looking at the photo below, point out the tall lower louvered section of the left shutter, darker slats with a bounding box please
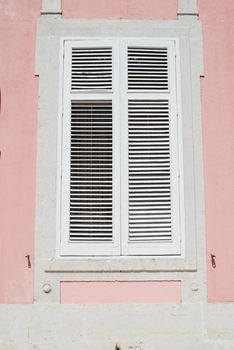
[70,101,112,242]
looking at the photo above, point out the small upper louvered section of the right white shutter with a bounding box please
[128,47,168,90]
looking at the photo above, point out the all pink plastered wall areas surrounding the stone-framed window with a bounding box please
[0,0,234,303]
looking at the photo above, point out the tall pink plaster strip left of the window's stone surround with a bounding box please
[0,0,40,303]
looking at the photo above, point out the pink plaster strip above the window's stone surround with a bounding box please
[62,0,178,19]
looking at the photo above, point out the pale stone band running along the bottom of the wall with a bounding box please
[0,304,234,350]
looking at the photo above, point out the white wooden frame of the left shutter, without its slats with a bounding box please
[60,40,120,256]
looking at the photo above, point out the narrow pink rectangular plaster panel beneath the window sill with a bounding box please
[60,281,181,304]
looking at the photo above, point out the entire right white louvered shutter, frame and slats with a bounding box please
[122,40,180,255]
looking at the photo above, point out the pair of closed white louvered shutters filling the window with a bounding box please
[60,38,183,256]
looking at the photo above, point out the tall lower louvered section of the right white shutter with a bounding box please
[128,100,172,242]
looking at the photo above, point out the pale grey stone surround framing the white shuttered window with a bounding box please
[35,16,206,302]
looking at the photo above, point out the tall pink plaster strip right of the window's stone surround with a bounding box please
[199,0,234,301]
